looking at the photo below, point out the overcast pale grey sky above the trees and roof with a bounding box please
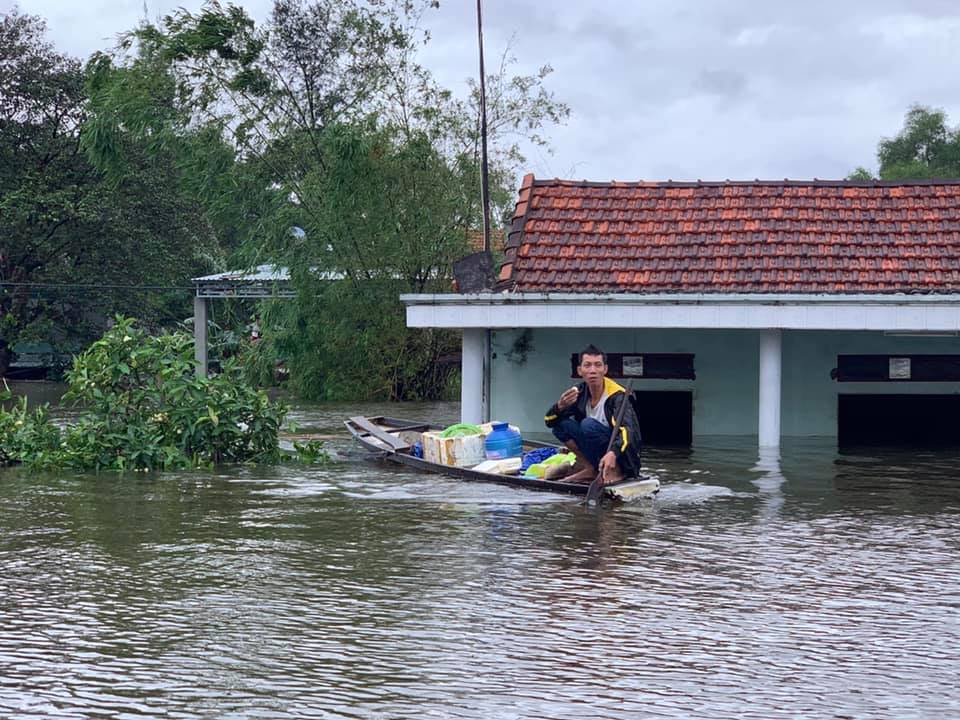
[7,0,960,180]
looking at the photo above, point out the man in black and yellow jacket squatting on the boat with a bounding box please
[544,345,640,485]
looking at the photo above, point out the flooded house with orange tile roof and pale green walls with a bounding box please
[401,175,960,447]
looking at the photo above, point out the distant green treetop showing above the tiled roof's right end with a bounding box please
[849,105,960,180]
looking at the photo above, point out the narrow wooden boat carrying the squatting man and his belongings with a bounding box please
[344,416,660,501]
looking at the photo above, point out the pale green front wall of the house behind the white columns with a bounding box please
[491,329,960,438]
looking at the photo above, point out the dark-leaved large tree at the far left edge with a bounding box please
[0,11,219,371]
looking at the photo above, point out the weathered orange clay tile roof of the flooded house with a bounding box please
[499,175,960,294]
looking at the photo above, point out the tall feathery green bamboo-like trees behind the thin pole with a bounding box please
[82,0,568,398]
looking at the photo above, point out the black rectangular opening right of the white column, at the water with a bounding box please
[837,395,960,447]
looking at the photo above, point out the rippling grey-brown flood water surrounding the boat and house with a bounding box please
[0,390,960,719]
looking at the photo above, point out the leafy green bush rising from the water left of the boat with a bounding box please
[0,317,326,470]
